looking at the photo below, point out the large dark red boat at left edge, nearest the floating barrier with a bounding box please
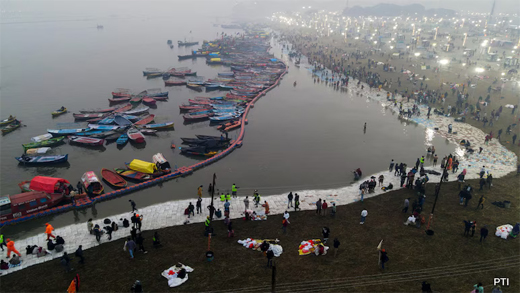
[0,191,64,221]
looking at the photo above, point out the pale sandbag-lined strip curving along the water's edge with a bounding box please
[2,64,517,274]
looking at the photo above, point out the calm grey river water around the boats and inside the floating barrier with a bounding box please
[0,1,455,237]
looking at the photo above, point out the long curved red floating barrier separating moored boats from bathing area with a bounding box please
[0,65,289,227]
